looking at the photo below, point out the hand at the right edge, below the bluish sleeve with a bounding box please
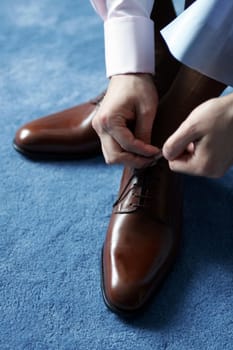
[163,94,233,177]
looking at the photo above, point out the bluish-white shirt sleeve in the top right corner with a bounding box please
[162,0,233,86]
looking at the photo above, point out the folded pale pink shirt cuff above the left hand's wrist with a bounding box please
[104,16,155,77]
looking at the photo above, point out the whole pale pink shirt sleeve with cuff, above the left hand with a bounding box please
[91,0,155,77]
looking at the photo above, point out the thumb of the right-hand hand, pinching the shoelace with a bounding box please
[163,118,201,161]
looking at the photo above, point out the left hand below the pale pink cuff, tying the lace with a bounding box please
[92,74,159,168]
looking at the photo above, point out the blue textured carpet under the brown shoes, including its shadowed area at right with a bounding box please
[0,0,233,350]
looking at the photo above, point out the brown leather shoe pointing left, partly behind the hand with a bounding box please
[13,93,104,159]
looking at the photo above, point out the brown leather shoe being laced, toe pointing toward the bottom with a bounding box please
[102,159,182,315]
